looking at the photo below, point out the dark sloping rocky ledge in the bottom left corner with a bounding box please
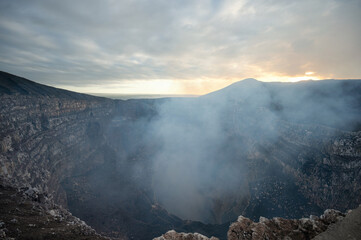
[0,180,109,240]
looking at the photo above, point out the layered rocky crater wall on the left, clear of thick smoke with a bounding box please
[0,73,115,205]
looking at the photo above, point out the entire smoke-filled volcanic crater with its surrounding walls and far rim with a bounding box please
[0,73,361,239]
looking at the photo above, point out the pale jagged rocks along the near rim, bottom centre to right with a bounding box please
[153,206,361,240]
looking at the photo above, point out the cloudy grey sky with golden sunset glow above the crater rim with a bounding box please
[0,0,361,94]
